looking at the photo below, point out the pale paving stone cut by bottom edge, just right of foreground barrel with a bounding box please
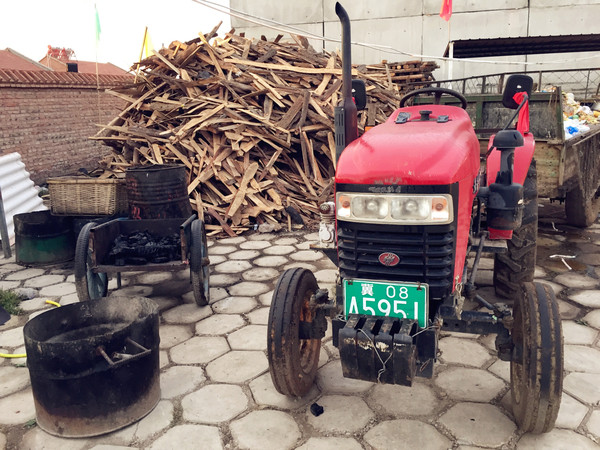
[148,424,223,450]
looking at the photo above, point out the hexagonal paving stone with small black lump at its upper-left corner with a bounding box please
[305,395,375,433]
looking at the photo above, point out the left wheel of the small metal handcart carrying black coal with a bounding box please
[74,222,108,302]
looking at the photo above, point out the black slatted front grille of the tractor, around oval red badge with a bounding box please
[338,221,455,300]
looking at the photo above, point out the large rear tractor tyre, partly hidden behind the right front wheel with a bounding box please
[494,160,538,298]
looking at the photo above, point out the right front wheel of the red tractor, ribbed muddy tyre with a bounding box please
[510,283,563,433]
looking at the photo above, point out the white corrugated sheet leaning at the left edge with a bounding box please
[0,153,48,241]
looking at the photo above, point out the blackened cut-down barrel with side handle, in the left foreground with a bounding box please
[23,297,160,437]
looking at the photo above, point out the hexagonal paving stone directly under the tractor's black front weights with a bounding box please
[366,382,441,417]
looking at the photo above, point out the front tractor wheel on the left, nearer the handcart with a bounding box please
[267,268,321,397]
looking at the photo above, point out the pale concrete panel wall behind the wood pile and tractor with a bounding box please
[230,0,600,79]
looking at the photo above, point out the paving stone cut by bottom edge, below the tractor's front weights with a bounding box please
[364,419,452,450]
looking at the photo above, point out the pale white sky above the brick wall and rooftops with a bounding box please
[0,0,231,70]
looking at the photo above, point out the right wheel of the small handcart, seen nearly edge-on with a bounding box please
[190,219,210,306]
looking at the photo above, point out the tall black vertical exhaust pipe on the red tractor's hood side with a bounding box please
[334,2,358,162]
